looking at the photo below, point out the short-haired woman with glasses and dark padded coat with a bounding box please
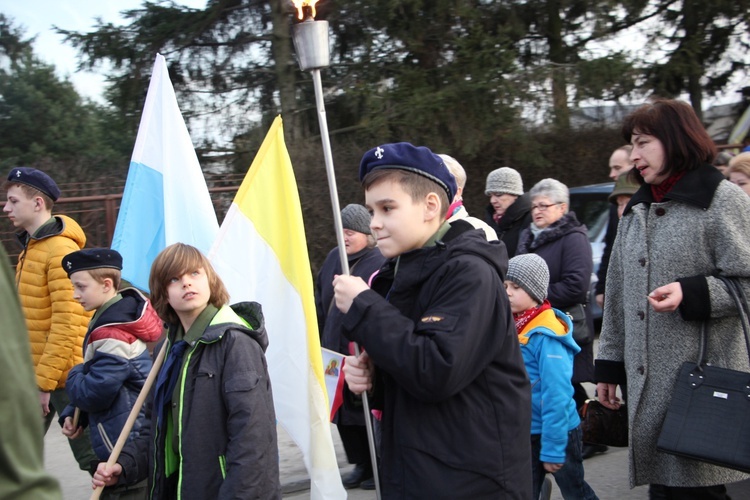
[517,179,594,410]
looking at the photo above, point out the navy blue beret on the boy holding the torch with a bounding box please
[359,142,456,203]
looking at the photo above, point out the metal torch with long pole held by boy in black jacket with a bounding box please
[293,17,381,500]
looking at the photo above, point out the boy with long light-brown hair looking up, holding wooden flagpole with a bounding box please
[94,243,281,498]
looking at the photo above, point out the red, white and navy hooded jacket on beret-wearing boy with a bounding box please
[60,288,163,460]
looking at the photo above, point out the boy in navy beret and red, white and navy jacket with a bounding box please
[60,248,162,498]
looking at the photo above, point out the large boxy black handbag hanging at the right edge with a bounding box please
[656,277,750,472]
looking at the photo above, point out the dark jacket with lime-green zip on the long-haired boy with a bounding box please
[118,302,281,499]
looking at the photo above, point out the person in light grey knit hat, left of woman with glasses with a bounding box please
[484,167,531,259]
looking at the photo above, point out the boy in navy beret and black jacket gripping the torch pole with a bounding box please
[333,143,531,498]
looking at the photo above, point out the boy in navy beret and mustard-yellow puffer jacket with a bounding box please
[3,167,96,472]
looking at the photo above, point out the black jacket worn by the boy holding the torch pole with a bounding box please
[344,221,531,499]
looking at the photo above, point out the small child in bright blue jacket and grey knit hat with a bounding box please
[505,254,597,500]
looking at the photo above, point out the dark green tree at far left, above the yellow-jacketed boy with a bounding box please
[0,14,132,178]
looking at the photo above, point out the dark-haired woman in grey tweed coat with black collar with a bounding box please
[595,100,750,499]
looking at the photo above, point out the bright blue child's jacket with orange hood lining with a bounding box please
[518,309,581,464]
